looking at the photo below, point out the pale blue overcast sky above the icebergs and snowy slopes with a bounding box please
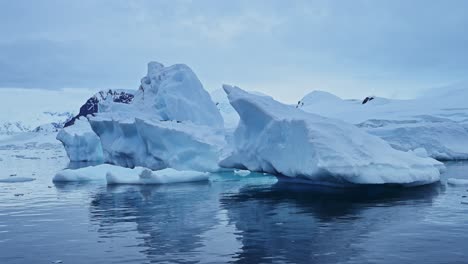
[0,0,468,102]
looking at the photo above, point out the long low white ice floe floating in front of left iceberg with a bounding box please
[53,164,209,184]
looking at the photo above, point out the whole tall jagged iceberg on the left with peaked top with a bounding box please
[58,62,225,171]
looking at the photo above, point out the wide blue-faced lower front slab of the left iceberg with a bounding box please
[90,113,224,171]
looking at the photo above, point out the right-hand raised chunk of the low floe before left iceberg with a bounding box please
[106,168,209,184]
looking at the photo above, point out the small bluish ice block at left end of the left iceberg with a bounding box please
[57,117,104,161]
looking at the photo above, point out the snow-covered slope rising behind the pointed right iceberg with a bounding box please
[299,88,468,160]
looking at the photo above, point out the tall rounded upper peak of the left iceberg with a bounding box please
[134,62,223,128]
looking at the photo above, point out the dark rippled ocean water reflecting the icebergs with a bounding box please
[0,145,468,264]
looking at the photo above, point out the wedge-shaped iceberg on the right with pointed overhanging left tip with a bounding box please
[220,85,443,185]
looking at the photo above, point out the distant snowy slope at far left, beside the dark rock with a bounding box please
[0,88,97,135]
